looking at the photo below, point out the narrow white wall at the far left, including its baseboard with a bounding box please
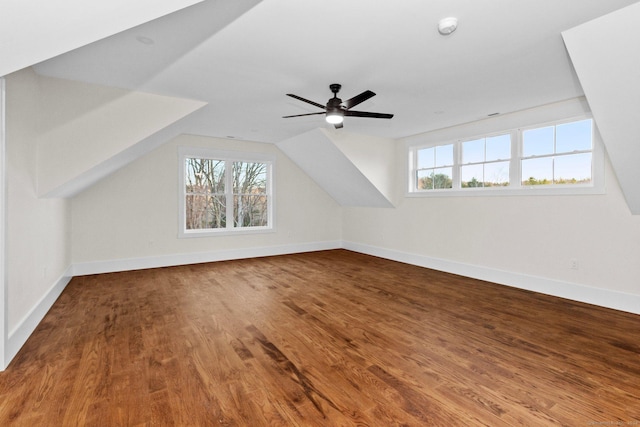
[5,70,71,360]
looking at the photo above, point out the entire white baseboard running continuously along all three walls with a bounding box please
[0,241,640,371]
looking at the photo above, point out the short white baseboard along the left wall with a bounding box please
[0,267,72,370]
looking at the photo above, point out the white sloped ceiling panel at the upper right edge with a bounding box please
[562,3,640,215]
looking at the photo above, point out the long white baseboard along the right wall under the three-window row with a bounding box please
[342,241,640,314]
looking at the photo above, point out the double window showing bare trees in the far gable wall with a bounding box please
[179,149,273,237]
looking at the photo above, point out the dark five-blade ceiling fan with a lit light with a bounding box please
[283,83,393,129]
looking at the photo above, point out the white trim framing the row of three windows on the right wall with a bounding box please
[405,114,606,197]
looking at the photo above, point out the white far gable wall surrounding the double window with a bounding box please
[72,135,341,274]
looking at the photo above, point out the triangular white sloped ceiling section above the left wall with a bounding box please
[37,77,206,197]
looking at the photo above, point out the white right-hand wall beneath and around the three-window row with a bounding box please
[343,100,640,313]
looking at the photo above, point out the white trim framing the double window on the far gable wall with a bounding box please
[178,147,276,238]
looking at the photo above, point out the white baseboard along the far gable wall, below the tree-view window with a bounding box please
[72,240,342,276]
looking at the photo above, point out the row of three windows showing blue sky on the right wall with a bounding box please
[409,118,604,195]
